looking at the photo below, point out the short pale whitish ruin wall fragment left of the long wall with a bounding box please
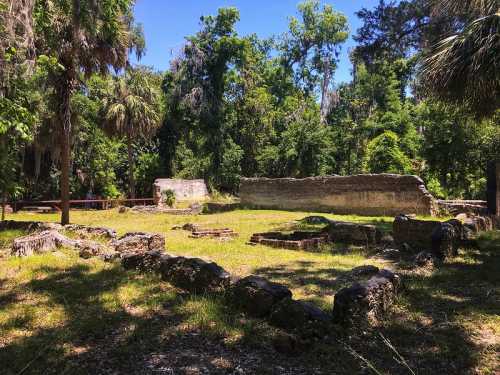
[153,178,208,204]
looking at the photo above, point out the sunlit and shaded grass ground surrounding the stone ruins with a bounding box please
[0,210,500,374]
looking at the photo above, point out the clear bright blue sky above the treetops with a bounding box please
[134,0,379,82]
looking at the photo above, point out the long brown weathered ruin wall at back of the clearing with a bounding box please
[240,174,435,216]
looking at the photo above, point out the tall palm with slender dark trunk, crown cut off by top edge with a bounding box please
[34,0,144,225]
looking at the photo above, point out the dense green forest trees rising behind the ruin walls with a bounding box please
[0,0,500,210]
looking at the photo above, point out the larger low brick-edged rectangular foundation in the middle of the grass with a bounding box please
[249,231,328,250]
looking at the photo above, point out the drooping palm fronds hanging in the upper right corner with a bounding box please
[420,0,500,117]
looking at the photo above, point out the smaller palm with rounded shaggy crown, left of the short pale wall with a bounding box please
[104,68,161,199]
